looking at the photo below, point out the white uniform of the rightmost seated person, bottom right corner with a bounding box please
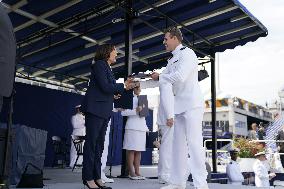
[253,159,270,187]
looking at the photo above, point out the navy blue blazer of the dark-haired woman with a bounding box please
[81,60,124,119]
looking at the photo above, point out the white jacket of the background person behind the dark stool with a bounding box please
[71,113,86,136]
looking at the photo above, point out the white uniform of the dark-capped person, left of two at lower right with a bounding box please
[226,160,244,185]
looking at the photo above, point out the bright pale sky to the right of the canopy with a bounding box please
[201,0,284,105]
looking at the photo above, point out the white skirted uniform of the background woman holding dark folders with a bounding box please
[121,94,149,151]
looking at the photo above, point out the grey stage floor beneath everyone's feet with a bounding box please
[11,166,273,189]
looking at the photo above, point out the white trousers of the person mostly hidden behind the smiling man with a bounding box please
[158,125,174,182]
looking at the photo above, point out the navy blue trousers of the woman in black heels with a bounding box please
[82,113,109,181]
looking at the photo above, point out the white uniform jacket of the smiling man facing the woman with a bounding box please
[159,44,204,114]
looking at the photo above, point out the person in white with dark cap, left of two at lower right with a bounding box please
[226,149,244,185]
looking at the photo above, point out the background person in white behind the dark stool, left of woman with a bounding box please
[69,105,86,167]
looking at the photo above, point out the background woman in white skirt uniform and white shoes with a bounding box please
[121,87,148,180]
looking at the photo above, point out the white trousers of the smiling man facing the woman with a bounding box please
[170,107,208,188]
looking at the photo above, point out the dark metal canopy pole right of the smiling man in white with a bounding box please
[211,54,217,173]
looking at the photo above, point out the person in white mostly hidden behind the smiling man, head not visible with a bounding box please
[157,75,174,184]
